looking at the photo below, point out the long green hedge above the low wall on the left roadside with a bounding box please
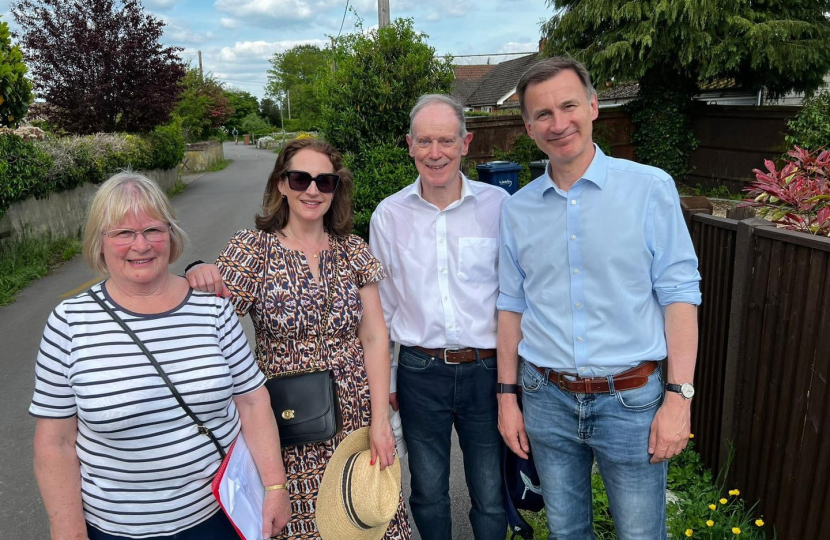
[0,123,185,217]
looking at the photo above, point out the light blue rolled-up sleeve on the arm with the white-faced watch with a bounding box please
[646,178,701,306]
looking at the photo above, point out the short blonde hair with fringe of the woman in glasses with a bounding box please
[84,171,188,274]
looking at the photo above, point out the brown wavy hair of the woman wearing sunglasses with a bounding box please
[256,138,354,236]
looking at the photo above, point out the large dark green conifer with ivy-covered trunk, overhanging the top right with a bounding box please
[542,0,830,177]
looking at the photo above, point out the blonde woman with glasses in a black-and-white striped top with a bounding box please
[29,173,290,540]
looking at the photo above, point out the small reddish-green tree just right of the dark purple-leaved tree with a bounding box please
[174,68,234,142]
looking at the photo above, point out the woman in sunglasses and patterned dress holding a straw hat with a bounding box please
[187,139,412,539]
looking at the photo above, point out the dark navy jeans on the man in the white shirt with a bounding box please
[398,347,507,540]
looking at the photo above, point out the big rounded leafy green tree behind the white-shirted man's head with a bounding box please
[320,19,453,153]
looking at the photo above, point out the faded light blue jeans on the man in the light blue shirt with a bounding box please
[521,363,668,540]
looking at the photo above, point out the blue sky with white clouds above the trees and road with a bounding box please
[0,0,553,98]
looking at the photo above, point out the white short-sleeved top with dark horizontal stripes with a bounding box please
[29,284,265,538]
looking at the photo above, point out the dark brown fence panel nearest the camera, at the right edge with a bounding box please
[725,226,830,540]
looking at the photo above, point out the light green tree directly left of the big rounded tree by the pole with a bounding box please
[265,45,328,130]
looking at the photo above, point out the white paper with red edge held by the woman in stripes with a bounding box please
[219,433,265,540]
